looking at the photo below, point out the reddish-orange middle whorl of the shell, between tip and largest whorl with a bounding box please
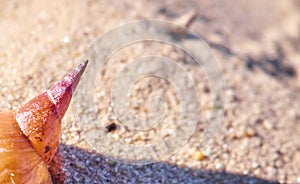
[16,92,61,164]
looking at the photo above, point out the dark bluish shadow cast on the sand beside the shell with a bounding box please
[59,144,279,184]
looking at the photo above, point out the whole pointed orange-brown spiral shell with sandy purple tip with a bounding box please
[0,61,87,184]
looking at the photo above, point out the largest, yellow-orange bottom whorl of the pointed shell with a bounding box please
[0,111,51,184]
